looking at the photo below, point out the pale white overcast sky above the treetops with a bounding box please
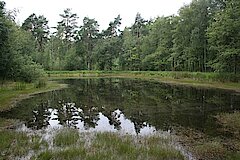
[4,0,192,29]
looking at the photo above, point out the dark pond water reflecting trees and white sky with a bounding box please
[0,78,240,135]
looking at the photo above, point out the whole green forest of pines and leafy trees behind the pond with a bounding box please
[0,0,240,82]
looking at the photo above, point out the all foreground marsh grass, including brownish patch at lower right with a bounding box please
[0,123,240,160]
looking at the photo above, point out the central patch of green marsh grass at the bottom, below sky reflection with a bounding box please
[32,129,184,160]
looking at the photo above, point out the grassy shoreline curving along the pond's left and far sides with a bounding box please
[0,71,240,112]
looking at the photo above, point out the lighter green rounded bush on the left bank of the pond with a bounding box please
[6,26,43,82]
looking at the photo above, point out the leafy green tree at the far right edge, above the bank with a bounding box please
[208,0,240,74]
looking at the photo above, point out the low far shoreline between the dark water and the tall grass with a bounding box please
[47,71,240,93]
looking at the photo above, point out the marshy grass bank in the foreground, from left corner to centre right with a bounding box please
[0,129,184,160]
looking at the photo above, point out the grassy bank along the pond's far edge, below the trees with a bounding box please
[47,71,240,92]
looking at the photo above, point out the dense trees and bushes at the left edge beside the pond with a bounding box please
[0,1,43,82]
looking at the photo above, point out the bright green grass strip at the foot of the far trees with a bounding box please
[47,71,240,82]
